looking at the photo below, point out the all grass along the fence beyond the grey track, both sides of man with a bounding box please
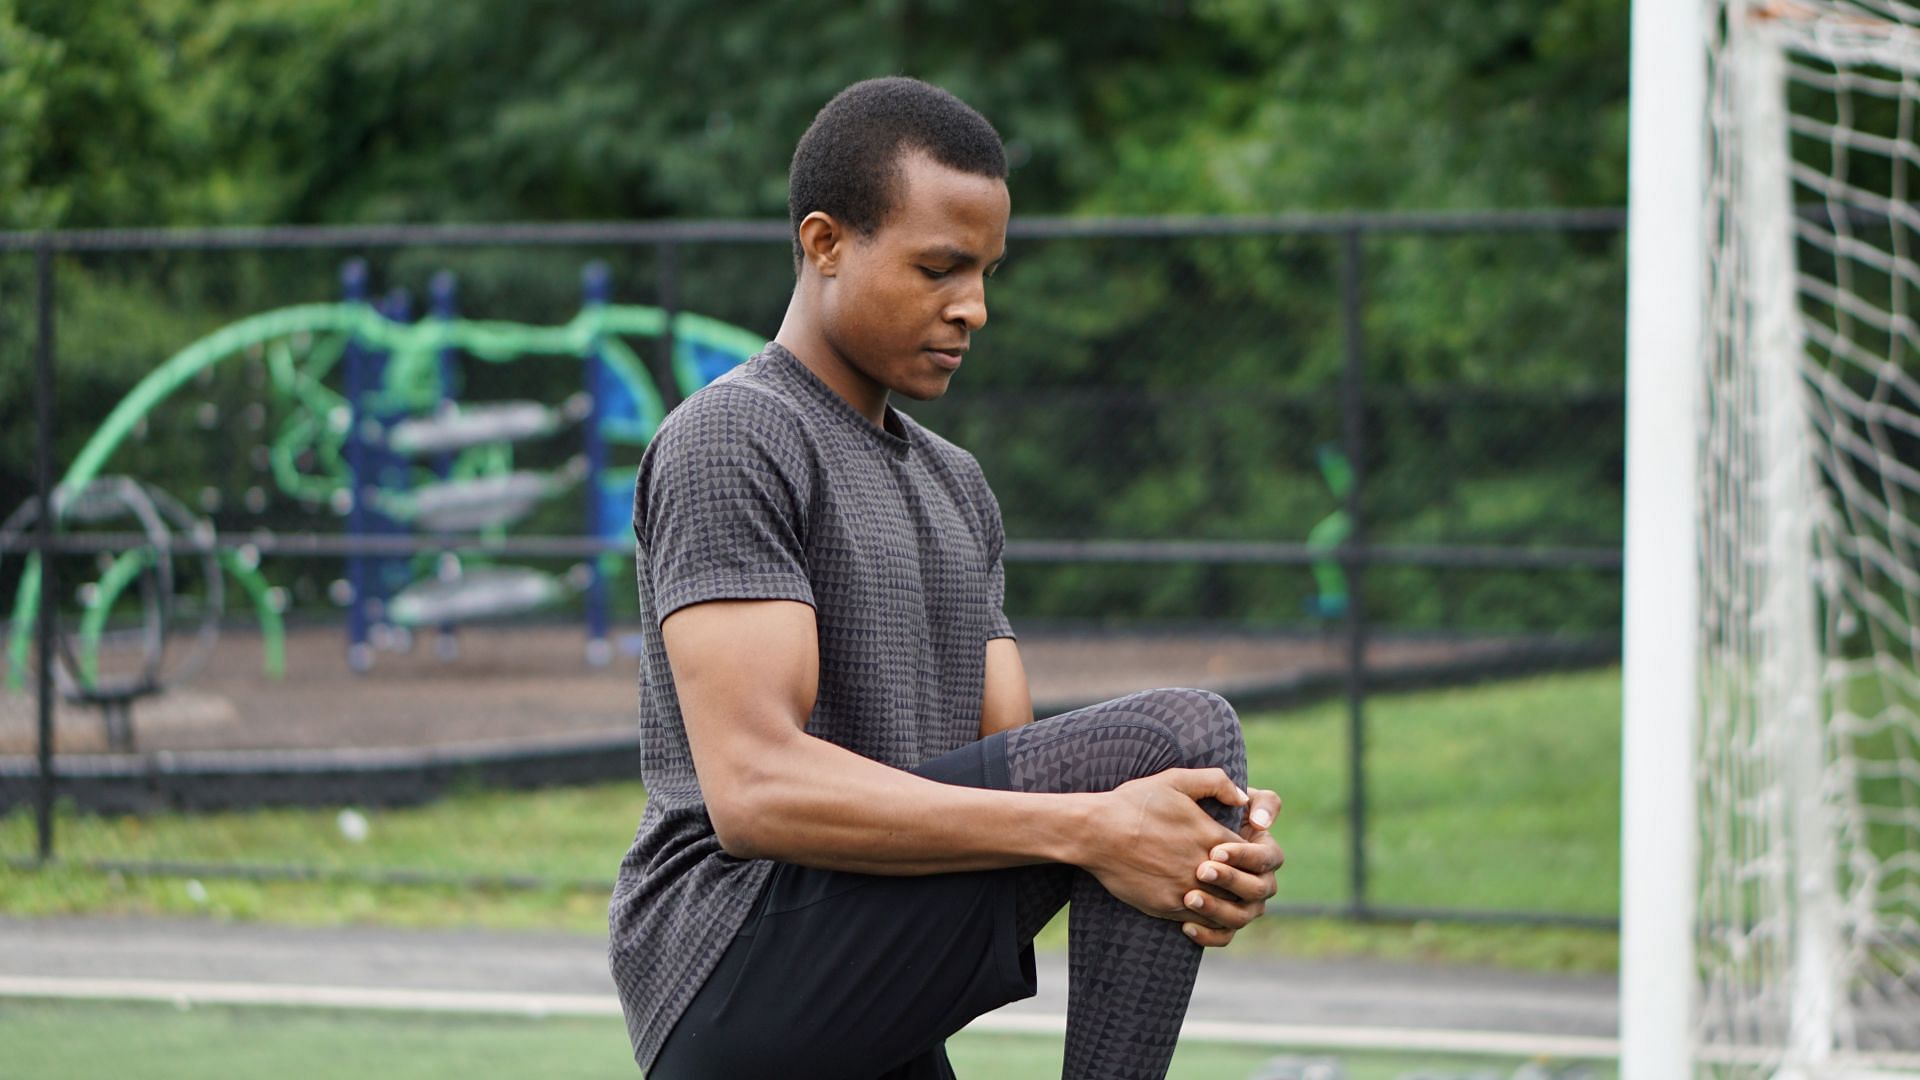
[0,671,1619,970]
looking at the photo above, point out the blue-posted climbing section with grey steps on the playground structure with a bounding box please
[336,263,762,671]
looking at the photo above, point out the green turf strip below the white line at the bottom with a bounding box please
[0,999,1613,1080]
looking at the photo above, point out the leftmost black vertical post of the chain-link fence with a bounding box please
[33,234,60,863]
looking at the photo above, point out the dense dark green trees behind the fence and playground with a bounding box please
[0,0,1626,619]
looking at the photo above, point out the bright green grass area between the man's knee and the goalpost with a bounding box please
[1246,671,1620,915]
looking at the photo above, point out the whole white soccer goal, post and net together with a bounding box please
[1620,0,1920,1080]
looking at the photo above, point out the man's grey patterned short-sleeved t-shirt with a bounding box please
[611,344,1012,1068]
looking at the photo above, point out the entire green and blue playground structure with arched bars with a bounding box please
[0,261,764,714]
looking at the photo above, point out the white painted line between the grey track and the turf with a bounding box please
[0,974,1620,1059]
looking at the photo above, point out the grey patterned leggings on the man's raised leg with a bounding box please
[1006,690,1246,1078]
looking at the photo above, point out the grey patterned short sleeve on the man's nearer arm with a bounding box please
[634,386,814,621]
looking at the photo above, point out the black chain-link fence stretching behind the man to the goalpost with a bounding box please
[0,211,1624,922]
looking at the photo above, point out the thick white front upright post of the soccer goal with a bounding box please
[1620,0,1707,1080]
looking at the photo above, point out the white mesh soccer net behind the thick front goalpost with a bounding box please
[1622,0,1920,1076]
